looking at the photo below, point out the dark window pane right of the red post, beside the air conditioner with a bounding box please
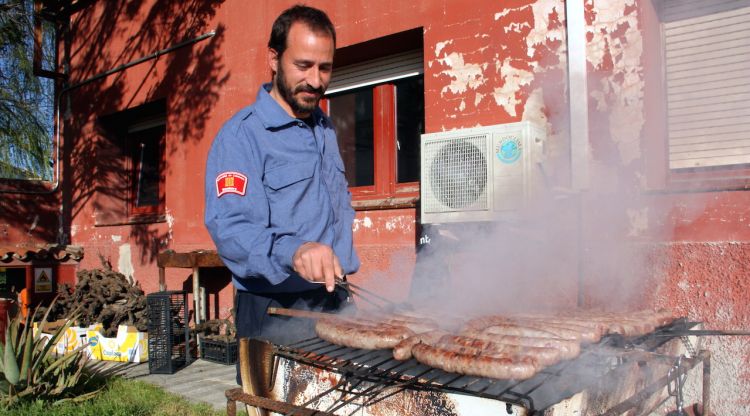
[395,76,424,183]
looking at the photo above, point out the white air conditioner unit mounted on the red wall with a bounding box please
[420,121,546,224]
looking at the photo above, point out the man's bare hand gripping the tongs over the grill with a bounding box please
[292,242,344,292]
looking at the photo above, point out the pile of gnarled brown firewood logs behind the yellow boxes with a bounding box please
[40,267,148,337]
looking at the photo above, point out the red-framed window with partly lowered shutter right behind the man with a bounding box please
[324,30,424,208]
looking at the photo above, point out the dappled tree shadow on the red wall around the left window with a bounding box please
[55,0,229,263]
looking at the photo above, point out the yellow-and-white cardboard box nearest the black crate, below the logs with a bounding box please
[87,325,148,363]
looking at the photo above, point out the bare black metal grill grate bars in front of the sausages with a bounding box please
[276,319,708,413]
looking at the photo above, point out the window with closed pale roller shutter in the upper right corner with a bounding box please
[657,0,750,176]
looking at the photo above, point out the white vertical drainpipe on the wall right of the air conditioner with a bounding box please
[565,0,590,306]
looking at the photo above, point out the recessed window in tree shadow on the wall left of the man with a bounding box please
[94,100,166,225]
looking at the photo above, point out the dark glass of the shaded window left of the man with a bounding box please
[131,126,164,207]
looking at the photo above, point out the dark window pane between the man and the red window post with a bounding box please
[328,88,375,186]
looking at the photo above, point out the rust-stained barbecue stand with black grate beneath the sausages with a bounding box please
[226,323,710,416]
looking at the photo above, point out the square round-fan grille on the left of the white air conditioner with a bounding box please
[423,135,488,212]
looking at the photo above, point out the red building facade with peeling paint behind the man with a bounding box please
[0,0,750,415]
